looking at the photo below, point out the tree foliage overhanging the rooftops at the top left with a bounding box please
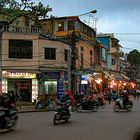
[0,0,52,21]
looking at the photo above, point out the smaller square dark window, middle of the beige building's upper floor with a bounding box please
[45,48,56,60]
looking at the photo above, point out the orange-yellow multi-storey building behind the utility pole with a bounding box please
[40,16,100,92]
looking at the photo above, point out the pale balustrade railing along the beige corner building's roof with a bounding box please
[0,26,41,34]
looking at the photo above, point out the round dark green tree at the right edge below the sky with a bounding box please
[127,50,140,67]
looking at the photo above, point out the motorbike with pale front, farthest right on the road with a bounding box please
[113,98,133,112]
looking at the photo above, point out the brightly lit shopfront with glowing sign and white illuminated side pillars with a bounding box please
[2,71,38,102]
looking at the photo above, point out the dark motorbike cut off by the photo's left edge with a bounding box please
[0,106,18,133]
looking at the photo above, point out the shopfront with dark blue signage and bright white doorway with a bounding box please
[39,72,68,99]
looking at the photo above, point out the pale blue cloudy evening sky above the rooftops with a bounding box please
[36,0,140,53]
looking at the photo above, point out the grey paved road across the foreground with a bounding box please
[0,100,140,140]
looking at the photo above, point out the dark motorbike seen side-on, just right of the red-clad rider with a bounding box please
[76,99,99,112]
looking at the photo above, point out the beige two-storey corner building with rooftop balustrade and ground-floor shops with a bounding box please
[0,16,71,101]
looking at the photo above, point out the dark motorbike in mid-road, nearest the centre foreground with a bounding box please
[53,101,71,125]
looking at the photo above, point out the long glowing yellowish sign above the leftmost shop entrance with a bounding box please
[2,71,36,79]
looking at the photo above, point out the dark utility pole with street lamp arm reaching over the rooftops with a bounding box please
[71,10,97,94]
